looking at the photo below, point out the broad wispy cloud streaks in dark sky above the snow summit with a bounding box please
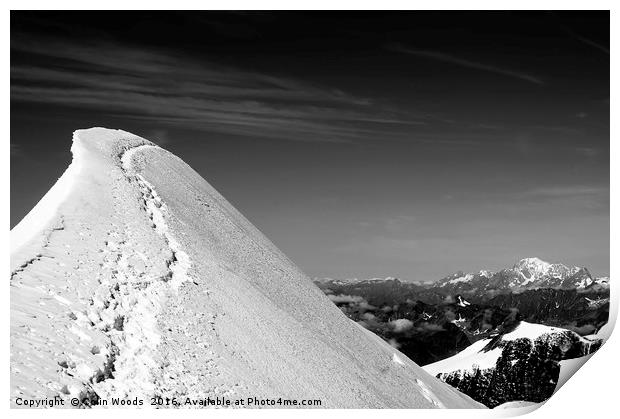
[11,38,429,143]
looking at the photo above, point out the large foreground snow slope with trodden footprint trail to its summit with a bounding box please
[10,128,481,408]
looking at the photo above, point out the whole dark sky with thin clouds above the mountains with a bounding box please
[11,11,609,280]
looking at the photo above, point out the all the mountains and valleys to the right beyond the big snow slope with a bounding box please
[315,258,609,407]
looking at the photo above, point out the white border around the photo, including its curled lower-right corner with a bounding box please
[0,4,620,419]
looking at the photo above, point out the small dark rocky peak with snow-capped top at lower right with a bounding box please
[424,322,602,407]
